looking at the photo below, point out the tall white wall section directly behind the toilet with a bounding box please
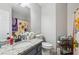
[41,3,56,48]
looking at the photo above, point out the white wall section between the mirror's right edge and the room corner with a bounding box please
[31,4,41,33]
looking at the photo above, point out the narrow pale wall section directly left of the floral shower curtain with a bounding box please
[67,3,79,35]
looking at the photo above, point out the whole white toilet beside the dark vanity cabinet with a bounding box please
[42,42,53,55]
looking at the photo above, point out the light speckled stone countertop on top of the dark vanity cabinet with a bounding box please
[0,39,43,55]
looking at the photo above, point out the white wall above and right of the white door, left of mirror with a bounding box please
[0,3,12,34]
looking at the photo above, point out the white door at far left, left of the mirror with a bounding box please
[0,9,11,40]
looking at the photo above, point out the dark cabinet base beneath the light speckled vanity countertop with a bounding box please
[18,43,42,55]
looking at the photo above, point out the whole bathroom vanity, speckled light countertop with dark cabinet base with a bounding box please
[0,39,43,55]
